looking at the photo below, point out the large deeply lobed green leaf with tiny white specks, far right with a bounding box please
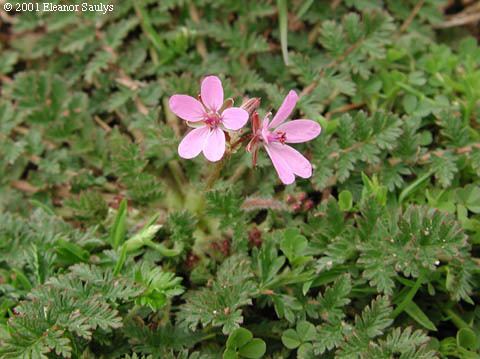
[358,207,468,294]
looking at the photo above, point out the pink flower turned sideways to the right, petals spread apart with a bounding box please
[247,91,322,184]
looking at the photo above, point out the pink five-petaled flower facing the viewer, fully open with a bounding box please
[169,76,249,162]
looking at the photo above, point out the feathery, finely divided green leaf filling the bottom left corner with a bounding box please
[0,265,138,358]
